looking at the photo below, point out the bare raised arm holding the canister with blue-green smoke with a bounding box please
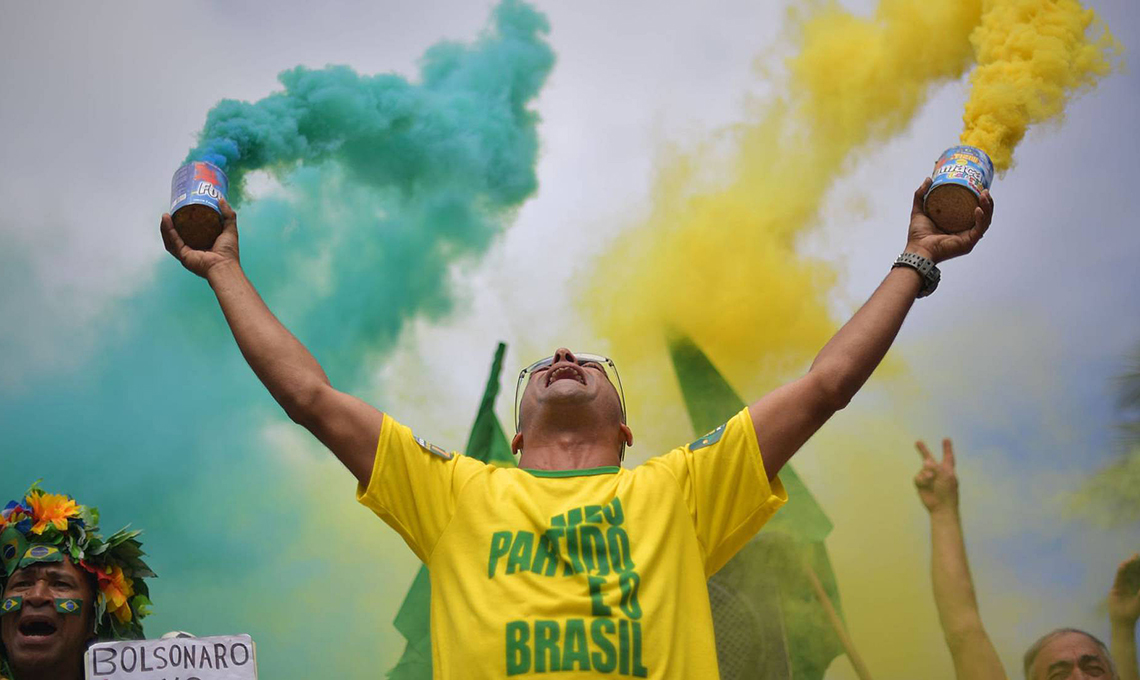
[161,201,384,485]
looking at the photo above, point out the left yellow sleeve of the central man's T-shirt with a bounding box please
[357,413,485,564]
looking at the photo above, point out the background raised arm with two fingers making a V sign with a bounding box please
[914,439,1005,680]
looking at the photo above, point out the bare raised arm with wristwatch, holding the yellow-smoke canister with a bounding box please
[749,179,994,478]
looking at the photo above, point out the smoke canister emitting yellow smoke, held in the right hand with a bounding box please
[922,146,994,234]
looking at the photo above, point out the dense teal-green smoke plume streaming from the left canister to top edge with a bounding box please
[187,0,554,207]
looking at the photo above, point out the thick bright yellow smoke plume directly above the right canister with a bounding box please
[962,0,1121,171]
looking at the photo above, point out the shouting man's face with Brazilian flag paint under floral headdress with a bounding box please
[0,559,95,675]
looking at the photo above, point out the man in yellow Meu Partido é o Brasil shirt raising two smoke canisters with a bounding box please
[161,180,993,679]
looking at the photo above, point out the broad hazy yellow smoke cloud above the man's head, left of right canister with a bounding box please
[584,0,982,411]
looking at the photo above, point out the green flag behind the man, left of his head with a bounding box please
[388,342,515,680]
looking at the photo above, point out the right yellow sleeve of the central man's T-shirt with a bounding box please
[645,408,788,576]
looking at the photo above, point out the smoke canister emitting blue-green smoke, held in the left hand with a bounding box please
[170,161,229,250]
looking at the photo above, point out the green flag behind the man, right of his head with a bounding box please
[668,337,844,680]
